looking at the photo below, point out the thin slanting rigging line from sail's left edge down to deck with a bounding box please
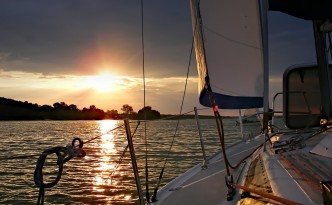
[152,22,195,201]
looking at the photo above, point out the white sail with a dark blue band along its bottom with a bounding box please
[191,0,264,109]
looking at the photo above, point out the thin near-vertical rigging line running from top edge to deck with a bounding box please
[141,0,150,202]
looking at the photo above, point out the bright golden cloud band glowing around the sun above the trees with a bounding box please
[0,70,197,113]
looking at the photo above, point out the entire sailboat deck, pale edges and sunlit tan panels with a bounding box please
[151,129,332,205]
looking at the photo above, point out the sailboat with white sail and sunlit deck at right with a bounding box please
[132,0,332,205]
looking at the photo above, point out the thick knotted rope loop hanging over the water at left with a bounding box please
[34,138,86,205]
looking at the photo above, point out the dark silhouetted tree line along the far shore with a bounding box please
[0,97,160,120]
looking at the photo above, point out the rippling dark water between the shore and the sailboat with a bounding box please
[0,119,260,204]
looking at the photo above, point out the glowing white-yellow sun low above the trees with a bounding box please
[84,74,118,92]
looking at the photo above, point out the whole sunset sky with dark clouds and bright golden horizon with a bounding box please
[0,0,315,115]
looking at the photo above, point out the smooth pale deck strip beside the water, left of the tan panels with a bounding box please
[153,135,263,204]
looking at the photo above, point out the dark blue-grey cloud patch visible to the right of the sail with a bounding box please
[269,12,316,77]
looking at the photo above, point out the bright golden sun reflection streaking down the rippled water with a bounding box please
[92,120,131,201]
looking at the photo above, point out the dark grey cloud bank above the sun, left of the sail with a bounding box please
[0,0,191,75]
